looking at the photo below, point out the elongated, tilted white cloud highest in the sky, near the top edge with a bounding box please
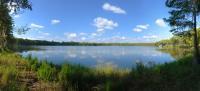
[102,3,126,14]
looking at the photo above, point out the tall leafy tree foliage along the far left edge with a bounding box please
[0,0,32,50]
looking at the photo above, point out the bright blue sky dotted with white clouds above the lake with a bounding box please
[13,0,172,42]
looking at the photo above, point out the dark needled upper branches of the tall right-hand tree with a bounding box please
[165,0,200,35]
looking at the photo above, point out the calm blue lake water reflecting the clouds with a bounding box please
[20,46,174,68]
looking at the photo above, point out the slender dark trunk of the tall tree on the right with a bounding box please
[193,12,200,64]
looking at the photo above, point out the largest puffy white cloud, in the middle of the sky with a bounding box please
[93,17,118,32]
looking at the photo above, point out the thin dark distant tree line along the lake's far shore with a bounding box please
[15,38,154,46]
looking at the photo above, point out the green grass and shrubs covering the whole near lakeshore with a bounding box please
[0,53,200,91]
